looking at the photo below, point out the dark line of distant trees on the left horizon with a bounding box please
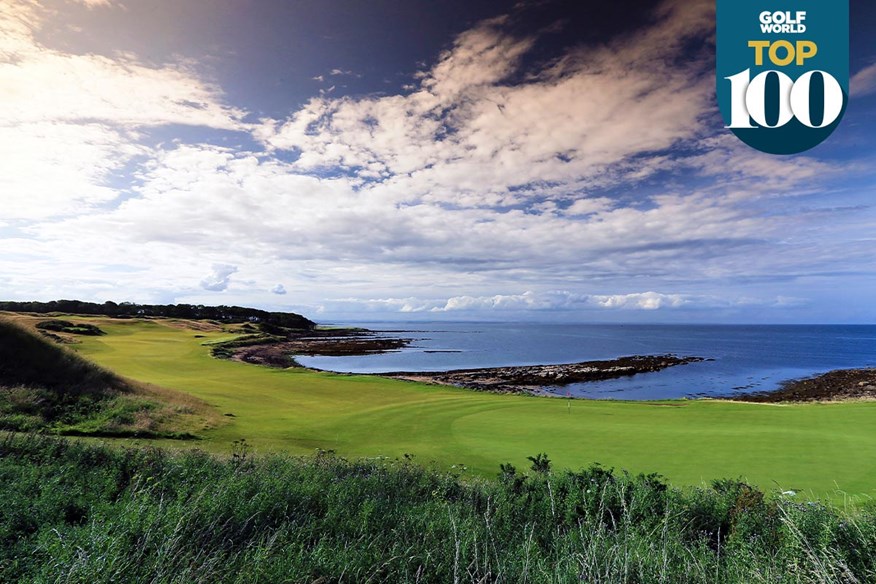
[0,300,316,329]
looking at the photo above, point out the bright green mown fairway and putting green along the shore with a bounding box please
[70,318,876,496]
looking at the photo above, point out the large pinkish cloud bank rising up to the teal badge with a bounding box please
[258,1,714,194]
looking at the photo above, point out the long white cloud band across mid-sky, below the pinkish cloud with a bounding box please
[48,141,768,271]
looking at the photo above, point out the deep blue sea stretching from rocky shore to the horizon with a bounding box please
[297,322,876,400]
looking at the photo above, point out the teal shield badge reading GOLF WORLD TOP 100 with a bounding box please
[715,0,849,154]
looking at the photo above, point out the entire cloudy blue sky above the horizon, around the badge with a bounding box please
[0,0,876,323]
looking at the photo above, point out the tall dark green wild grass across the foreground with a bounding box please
[0,435,876,583]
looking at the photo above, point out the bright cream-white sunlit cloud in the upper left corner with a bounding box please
[0,1,246,219]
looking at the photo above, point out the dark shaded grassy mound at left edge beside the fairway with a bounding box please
[0,319,218,438]
